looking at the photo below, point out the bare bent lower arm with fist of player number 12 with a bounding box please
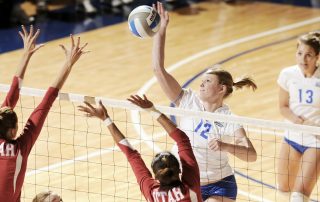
[209,128,257,162]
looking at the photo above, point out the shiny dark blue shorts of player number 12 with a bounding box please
[201,175,238,201]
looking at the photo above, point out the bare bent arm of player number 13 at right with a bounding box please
[279,87,304,124]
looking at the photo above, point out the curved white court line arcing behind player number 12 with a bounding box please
[131,17,320,202]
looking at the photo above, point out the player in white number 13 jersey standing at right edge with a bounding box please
[278,32,320,202]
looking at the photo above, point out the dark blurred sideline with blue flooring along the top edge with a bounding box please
[0,0,320,53]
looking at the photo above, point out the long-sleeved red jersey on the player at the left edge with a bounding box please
[0,82,59,202]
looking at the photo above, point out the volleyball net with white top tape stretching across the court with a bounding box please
[0,85,320,202]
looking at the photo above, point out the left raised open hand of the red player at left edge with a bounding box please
[19,25,44,56]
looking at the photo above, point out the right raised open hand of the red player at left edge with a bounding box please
[60,34,90,66]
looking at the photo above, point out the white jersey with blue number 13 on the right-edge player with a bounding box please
[278,65,320,148]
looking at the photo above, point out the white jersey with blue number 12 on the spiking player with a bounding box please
[173,89,242,184]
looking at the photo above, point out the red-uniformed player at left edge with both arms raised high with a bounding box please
[0,28,87,202]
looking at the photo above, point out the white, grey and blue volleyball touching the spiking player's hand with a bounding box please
[128,5,160,38]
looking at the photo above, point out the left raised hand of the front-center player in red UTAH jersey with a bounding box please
[78,101,109,121]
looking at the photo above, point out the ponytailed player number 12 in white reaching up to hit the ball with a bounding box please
[153,2,257,202]
